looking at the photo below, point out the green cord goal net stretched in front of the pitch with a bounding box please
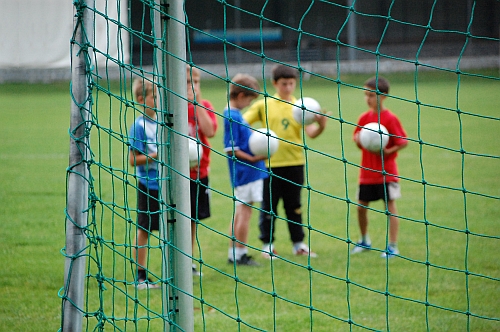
[59,0,500,331]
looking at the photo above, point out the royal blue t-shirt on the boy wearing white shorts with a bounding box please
[224,108,269,187]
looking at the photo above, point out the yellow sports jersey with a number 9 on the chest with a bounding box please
[243,95,305,167]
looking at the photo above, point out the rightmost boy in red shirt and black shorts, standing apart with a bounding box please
[351,76,407,258]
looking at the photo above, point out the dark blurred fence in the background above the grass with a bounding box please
[130,0,500,65]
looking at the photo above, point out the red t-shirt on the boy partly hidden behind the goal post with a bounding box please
[188,100,217,179]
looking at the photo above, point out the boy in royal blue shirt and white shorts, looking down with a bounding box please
[224,74,269,266]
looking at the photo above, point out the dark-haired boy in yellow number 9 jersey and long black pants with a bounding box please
[243,65,327,258]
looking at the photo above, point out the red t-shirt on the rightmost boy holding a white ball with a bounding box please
[354,109,406,184]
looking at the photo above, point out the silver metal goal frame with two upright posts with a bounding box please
[62,0,194,331]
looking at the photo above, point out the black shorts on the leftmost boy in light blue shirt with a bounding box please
[137,182,161,232]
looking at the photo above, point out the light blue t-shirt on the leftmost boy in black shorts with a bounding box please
[129,116,159,190]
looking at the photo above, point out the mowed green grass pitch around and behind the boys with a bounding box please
[0,68,500,331]
